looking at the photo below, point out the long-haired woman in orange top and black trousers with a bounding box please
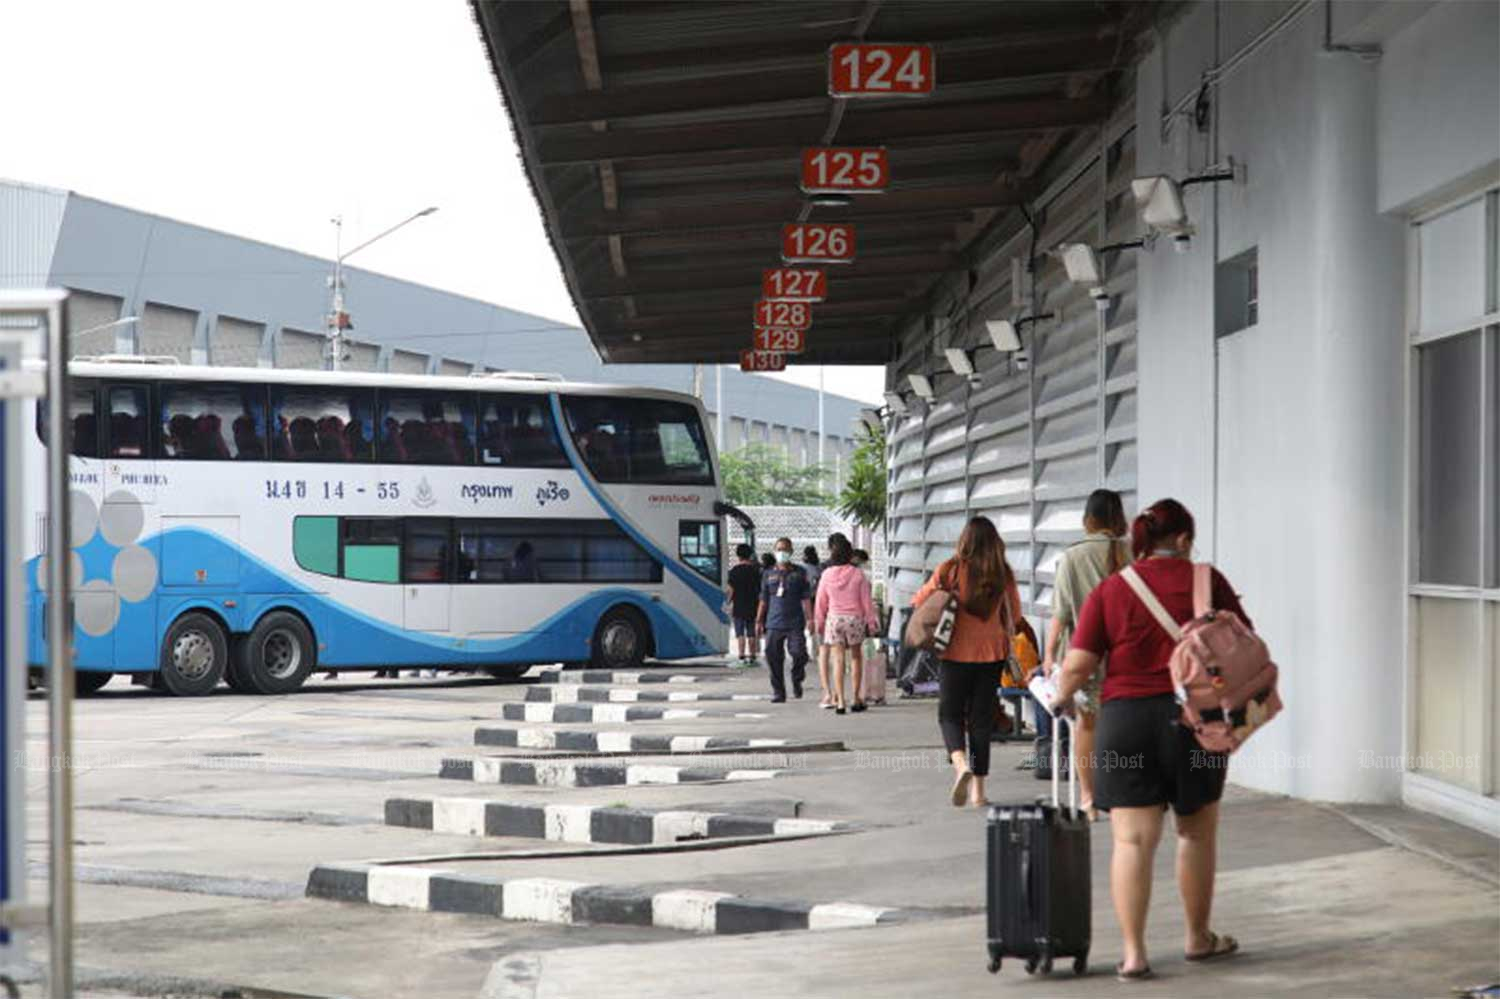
[912,518,1022,807]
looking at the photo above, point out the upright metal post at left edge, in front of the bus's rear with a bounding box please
[47,297,74,999]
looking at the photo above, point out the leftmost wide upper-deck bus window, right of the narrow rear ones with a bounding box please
[158,381,266,462]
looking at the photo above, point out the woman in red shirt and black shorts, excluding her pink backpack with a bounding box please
[1049,500,1251,981]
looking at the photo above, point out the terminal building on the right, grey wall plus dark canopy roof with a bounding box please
[471,0,1500,834]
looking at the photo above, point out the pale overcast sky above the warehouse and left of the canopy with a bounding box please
[0,0,882,402]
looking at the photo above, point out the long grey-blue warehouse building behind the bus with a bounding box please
[0,180,860,489]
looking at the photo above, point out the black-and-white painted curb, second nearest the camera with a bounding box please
[386,798,852,846]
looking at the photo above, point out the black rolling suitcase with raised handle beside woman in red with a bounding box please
[986,717,1092,975]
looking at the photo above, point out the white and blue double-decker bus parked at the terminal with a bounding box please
[27,359,743,695]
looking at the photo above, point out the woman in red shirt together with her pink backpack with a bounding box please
[1032,500,1281,981]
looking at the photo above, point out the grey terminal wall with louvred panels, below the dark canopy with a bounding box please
[890,2,1500,834]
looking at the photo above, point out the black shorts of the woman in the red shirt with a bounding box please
[1094,695,1229,815]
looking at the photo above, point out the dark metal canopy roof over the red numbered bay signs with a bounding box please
[471,0,1155,365]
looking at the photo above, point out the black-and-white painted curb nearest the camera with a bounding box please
[298,864,894,935]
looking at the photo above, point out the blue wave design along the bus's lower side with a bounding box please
[26,528,714,672]
